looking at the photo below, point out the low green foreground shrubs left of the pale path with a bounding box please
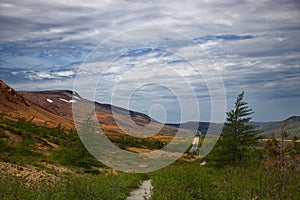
[0,174,146,200]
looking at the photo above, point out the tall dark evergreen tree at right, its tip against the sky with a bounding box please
[213,92,261,165]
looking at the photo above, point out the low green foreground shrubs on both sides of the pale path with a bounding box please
[0,161,300,200]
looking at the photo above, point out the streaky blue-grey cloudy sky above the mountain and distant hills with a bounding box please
[0,0,300,122]
